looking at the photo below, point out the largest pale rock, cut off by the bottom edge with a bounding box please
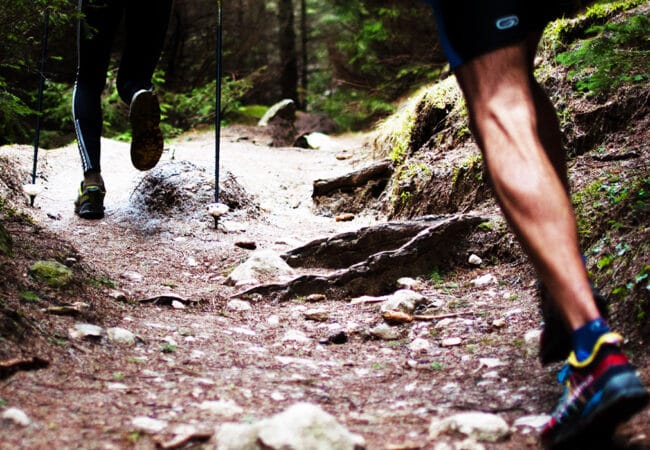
[215,403,365,450]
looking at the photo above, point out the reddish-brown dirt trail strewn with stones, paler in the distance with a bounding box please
[0,130,650,449]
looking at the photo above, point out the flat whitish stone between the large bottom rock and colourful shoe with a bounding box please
[429,412,510,442]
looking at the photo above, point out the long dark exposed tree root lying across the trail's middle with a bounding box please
[235,215,486,300]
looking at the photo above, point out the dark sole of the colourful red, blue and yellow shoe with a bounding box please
[544,373,650,450]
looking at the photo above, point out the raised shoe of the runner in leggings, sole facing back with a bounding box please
[129,89,163,170]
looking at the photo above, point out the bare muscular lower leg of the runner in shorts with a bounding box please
[455,37,599,330]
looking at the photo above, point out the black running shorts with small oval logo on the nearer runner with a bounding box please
[424,0,589,69]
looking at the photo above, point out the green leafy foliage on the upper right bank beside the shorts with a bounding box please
[557,14,650,95]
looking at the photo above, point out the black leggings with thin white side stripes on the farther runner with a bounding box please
[72,0,172,173]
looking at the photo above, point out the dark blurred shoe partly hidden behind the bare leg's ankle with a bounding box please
[539,283,608,365]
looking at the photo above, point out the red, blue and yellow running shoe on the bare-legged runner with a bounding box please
[542,332,649,449]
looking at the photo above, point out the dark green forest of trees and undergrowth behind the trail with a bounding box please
[0,0,445,148]
